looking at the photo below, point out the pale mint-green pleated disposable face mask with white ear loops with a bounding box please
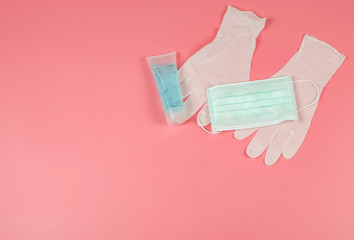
[198,76,318,133]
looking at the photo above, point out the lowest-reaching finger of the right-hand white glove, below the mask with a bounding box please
[264,130,291,166]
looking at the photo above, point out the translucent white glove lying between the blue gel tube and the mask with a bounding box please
[178,6,265,120]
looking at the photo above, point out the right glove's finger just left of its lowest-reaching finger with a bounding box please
[246,126,278,158]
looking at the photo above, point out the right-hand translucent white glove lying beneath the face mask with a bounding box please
[234,35,345,165]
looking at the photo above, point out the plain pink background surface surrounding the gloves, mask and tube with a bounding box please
[0,0,354,240]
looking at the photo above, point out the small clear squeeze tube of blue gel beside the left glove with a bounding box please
[146,52,185,125]
